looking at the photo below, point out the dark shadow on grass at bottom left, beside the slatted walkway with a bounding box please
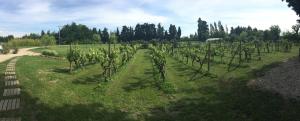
[19,92,136,121]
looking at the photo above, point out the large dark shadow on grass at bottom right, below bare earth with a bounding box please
[152,57,300,121]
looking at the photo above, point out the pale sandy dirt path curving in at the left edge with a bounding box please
[0,47,40,63]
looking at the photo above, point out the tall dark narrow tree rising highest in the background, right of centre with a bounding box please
[197,18,209,42]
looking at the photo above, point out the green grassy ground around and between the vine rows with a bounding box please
[0,46,300,121]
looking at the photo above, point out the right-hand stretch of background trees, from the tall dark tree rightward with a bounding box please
[195,18,286,42]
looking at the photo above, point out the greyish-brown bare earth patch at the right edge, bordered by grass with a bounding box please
[253,59,300,99]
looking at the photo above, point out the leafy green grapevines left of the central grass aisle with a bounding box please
[67,45,137,80]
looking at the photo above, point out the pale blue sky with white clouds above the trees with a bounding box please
[0,0,299,37]
